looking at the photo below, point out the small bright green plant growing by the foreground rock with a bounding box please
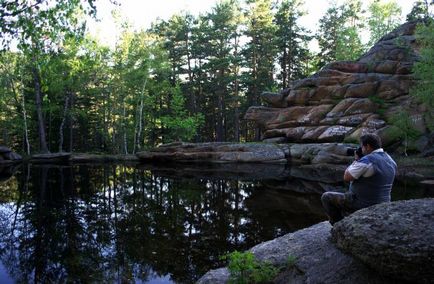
[225,251,279,284]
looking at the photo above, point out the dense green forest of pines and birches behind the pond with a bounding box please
[0,0,434,154]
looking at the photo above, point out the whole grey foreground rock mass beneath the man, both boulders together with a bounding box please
[198,198,434,284]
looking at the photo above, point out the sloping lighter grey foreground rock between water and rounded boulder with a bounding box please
[197,222,400,284]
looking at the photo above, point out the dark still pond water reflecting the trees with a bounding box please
[0,165,423,283]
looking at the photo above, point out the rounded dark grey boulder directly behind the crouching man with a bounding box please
[332,199,434,283]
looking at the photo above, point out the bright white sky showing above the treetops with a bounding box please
[89,0,415,47]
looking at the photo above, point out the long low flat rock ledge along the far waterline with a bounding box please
[137,142,357,165]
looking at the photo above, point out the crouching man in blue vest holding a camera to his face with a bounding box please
[321,134,396,225]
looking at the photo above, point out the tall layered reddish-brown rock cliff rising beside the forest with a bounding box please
[245,22,427,151]
